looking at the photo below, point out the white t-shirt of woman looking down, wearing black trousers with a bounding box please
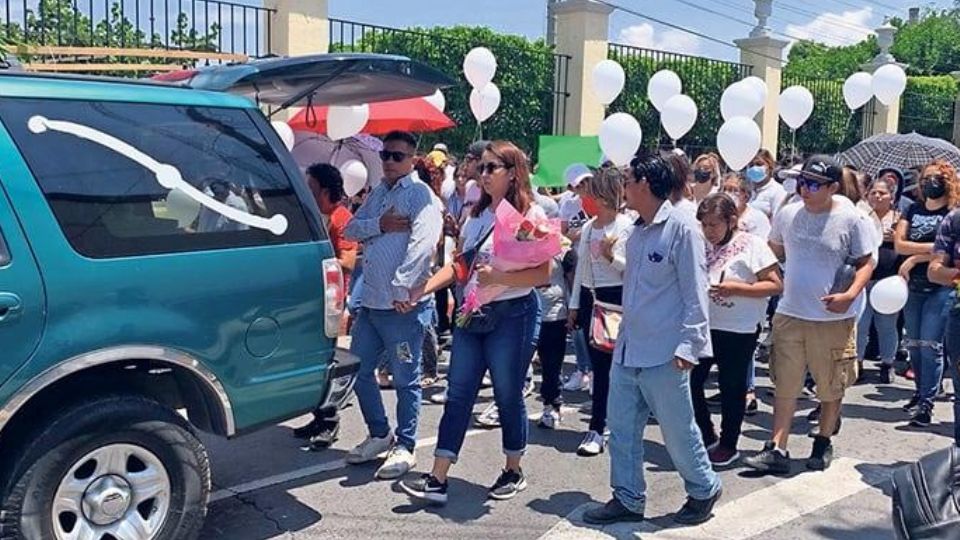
[707,232,777,334]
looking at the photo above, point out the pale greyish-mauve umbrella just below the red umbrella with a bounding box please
[291,131,383,187]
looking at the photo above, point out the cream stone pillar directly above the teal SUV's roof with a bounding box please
[263,0,330,56]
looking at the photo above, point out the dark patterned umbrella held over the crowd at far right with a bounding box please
[840,133,960,176]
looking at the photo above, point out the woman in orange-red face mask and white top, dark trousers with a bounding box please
[567,167,633,456]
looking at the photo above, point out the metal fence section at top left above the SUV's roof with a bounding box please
[0,0,275,56]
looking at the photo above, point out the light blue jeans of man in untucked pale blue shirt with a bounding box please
[607,361,720,513]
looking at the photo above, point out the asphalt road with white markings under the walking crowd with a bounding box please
[195,344,953,540]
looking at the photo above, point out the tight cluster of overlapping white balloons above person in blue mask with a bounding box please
[717,76,767,170]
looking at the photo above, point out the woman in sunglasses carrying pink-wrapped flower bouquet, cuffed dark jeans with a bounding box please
[401,141,560,504]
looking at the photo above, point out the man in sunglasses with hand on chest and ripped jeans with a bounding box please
[344,132,443,480]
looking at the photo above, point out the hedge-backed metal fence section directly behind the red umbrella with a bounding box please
[330,19,570,156]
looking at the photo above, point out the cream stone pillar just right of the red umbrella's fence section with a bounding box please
[553,0,613,135]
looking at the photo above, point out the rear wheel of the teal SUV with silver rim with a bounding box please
[0,396,210,540]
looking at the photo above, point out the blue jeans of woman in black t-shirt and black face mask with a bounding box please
[903,287,950,406]
